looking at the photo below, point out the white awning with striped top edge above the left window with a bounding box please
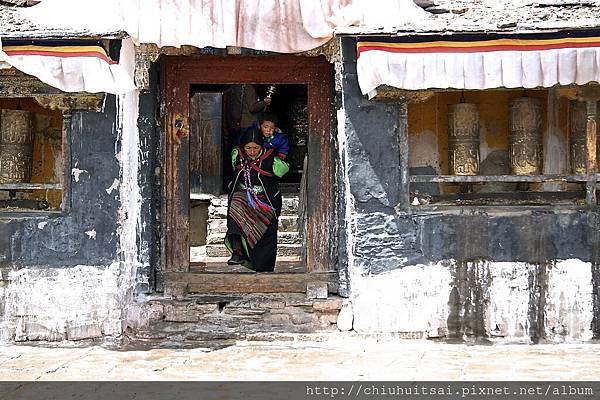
[0,42,135,94]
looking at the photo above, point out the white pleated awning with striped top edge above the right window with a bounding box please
[357,36,600,95]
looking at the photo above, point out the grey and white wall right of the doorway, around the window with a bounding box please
[338,38,600,342]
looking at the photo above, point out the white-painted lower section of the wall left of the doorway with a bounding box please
[0,262,122,342]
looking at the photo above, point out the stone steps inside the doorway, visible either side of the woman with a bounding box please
[205,193,302,261]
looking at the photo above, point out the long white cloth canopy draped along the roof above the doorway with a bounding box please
[15,0,428,53]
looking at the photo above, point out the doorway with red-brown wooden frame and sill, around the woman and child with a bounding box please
[158,55,337,293]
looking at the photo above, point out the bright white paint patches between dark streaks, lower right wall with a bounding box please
[350,259,593,342]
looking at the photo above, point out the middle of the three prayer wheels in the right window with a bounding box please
[508,97,543,175]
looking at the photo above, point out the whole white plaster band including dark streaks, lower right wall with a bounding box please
[350,259,593,343]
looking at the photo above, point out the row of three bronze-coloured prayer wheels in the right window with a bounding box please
[448,97,587,175]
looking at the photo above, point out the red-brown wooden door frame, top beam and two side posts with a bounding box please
[158,55,335,283]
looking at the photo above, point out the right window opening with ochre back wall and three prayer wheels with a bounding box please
[408,90,595,206]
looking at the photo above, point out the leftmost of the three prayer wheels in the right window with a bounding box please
[448,103,479,175]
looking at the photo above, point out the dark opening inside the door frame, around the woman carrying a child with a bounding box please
[189,83,308,273]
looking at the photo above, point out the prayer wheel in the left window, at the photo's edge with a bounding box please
[0,110,33,183]
